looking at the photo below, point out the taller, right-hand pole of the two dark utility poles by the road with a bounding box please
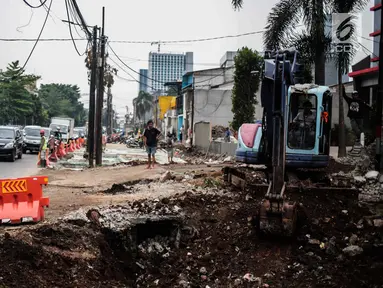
[96,7,106,165]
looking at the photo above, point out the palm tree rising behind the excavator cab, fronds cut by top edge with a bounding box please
[232,0,369,85]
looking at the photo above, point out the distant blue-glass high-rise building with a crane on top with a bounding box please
[147,52,193,93]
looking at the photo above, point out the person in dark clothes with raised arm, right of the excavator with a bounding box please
[343,85,373,143]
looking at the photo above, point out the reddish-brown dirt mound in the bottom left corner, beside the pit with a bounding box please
[0,225,133,288]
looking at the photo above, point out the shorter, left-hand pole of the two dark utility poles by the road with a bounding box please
[87,26,97,167]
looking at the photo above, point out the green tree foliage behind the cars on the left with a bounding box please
[0,61,87,126]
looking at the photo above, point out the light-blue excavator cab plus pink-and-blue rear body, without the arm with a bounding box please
[236,84,332,168]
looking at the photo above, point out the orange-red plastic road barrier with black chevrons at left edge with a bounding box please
[0,176,49,224]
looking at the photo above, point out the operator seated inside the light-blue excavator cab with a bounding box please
[291,100,316,149]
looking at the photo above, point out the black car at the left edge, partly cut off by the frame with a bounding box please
[0,126,23,162]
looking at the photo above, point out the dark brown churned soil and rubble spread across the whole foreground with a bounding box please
[0,179,383,288]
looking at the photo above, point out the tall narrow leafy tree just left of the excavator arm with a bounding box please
[231,47,263,130]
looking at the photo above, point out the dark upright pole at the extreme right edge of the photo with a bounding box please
[375,7,383,171]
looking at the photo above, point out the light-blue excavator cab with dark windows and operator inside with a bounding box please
[285,84,332,168]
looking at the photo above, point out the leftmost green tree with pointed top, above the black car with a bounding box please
[0,61,40,124]
